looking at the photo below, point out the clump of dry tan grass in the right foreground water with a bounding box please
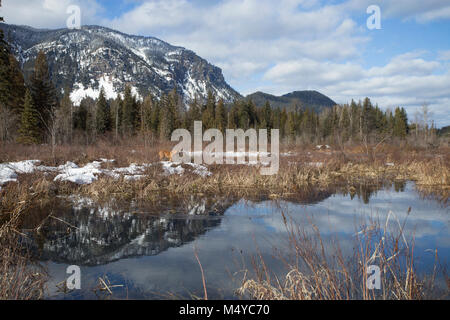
[237,214,450,300]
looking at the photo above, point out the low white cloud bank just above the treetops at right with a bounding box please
[259,52,450,126]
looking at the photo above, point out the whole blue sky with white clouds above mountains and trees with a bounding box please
[1,0,450,127]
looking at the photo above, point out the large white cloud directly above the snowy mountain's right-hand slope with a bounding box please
[105,0,368,85]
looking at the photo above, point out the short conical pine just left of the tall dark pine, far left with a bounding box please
[17,90,40,144]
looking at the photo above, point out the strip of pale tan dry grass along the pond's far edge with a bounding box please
[79,161,450,208]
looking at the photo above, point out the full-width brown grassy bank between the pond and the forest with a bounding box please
[1,143,450,202]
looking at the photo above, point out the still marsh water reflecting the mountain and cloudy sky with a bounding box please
[25,182,450,299]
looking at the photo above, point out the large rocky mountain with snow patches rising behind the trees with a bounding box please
[0,24,240,103]
